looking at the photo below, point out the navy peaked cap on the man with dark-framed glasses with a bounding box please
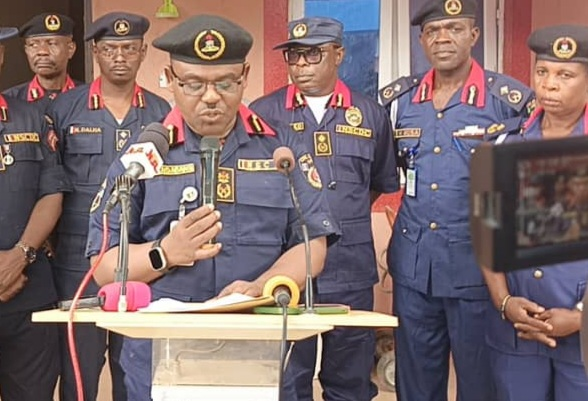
[274,17,343,49]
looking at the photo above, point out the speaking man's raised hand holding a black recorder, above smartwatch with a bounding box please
[161,205,222,266]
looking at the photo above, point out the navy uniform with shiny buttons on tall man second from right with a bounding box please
[381,61,532,401]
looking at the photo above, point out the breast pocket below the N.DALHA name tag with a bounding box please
[64,134,104,185]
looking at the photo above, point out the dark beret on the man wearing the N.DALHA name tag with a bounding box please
[84,12,150,42]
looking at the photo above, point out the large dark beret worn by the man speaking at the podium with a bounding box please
[153,15,253,65]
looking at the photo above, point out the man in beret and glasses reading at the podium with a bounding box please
[88,15,334,401]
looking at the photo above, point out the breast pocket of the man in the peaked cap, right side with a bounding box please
[334,135,375,184]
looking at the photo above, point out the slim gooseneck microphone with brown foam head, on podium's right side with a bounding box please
[273,146,315,313]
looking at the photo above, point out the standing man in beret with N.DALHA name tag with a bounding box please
[47,12,170,401]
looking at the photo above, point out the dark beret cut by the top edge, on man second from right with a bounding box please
[410,0,478,28]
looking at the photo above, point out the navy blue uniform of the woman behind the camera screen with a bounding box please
[486,109,588,401]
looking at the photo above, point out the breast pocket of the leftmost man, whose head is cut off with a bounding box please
[7,142,43,191]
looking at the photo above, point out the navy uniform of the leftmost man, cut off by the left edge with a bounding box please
[0,92,68,401]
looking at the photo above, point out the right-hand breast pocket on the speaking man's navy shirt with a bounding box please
[235,172,293,246]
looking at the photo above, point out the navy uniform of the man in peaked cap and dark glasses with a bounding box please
[251,81,398,401]
